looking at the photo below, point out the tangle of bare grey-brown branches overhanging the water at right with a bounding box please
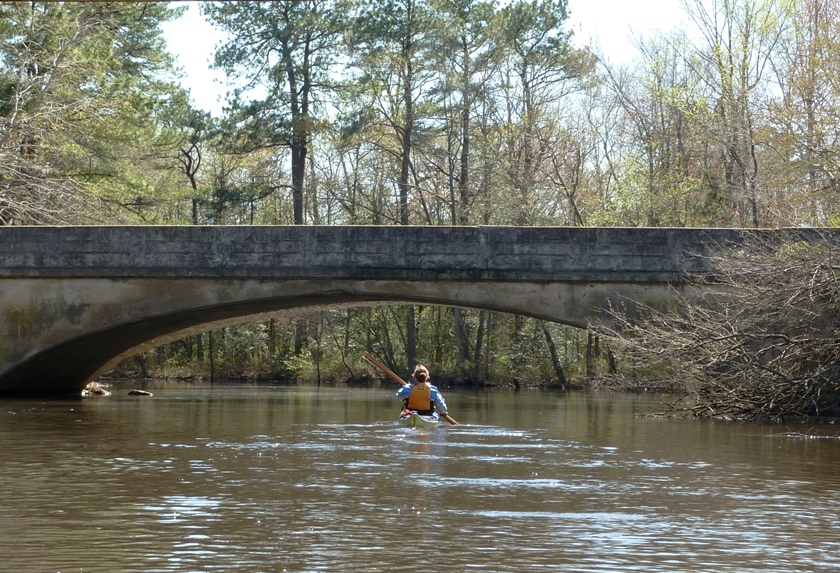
[606,232,840,421]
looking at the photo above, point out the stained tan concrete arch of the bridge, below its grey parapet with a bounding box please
[0,279,684,395]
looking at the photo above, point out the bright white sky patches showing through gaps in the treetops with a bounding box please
[164,0,683,115]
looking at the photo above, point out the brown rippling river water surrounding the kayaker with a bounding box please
[0,384,840,573]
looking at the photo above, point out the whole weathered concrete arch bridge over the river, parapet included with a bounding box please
[0,227,836,394]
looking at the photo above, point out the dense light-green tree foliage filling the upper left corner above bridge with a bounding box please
[0,3,185,224]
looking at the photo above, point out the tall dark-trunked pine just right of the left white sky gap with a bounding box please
[204,0,340,225]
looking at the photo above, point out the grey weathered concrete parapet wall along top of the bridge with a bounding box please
[0,226,744,282]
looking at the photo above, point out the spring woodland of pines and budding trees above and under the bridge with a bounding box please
[0,0,840,416]
